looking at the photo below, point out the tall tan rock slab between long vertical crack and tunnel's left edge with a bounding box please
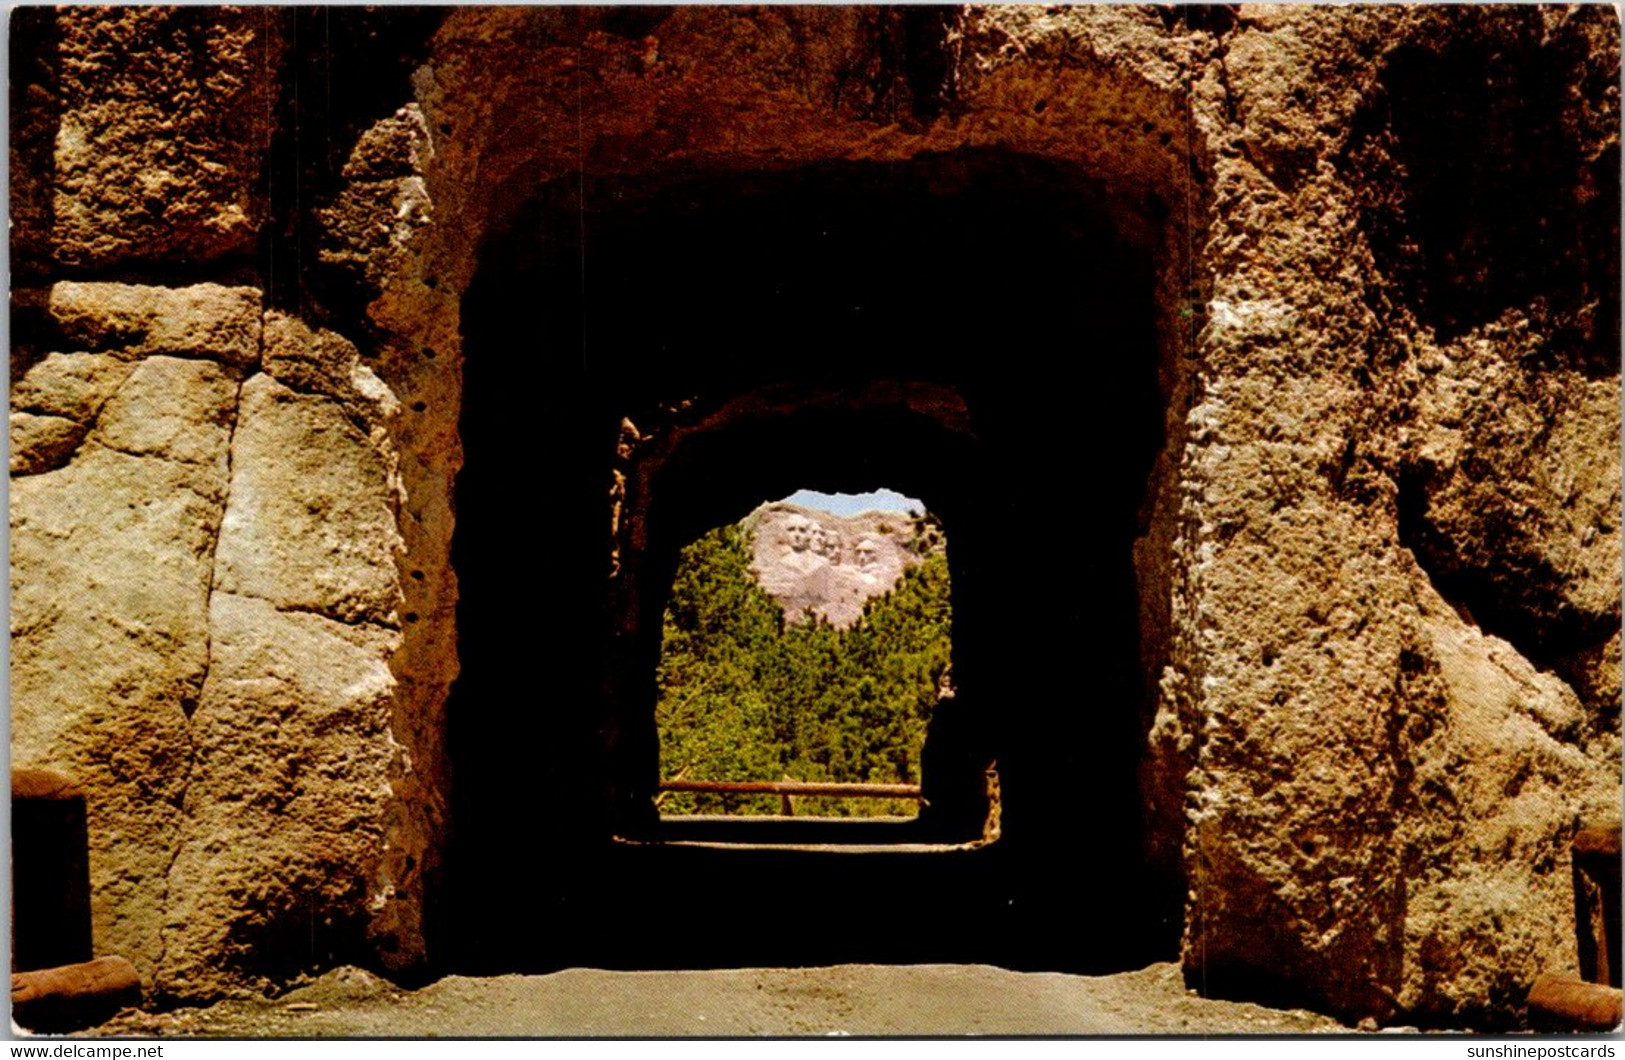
[159,314,401,997]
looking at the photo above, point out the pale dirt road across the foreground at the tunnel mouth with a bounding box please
[96,964,1349,1037]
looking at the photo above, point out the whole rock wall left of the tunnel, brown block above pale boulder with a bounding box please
[10,8,425,998]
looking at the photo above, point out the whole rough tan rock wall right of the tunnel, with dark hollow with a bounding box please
[1137,7,1620,1021]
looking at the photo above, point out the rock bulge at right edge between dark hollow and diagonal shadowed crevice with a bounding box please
[1402,333,1620,721]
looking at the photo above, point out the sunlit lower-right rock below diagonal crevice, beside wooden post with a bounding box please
[1398,575,1619,1016]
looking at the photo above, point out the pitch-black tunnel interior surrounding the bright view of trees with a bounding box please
[442,153,1180,972]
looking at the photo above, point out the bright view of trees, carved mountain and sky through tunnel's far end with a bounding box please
[655,491,952,819]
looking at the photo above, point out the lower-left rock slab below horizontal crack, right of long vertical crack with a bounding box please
[156,589,400,997]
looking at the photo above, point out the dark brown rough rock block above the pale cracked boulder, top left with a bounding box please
[50,7,281,268]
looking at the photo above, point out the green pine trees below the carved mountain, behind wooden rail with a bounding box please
[657,515,951,816]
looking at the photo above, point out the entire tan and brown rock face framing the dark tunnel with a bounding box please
[11,5,1622,1026]
